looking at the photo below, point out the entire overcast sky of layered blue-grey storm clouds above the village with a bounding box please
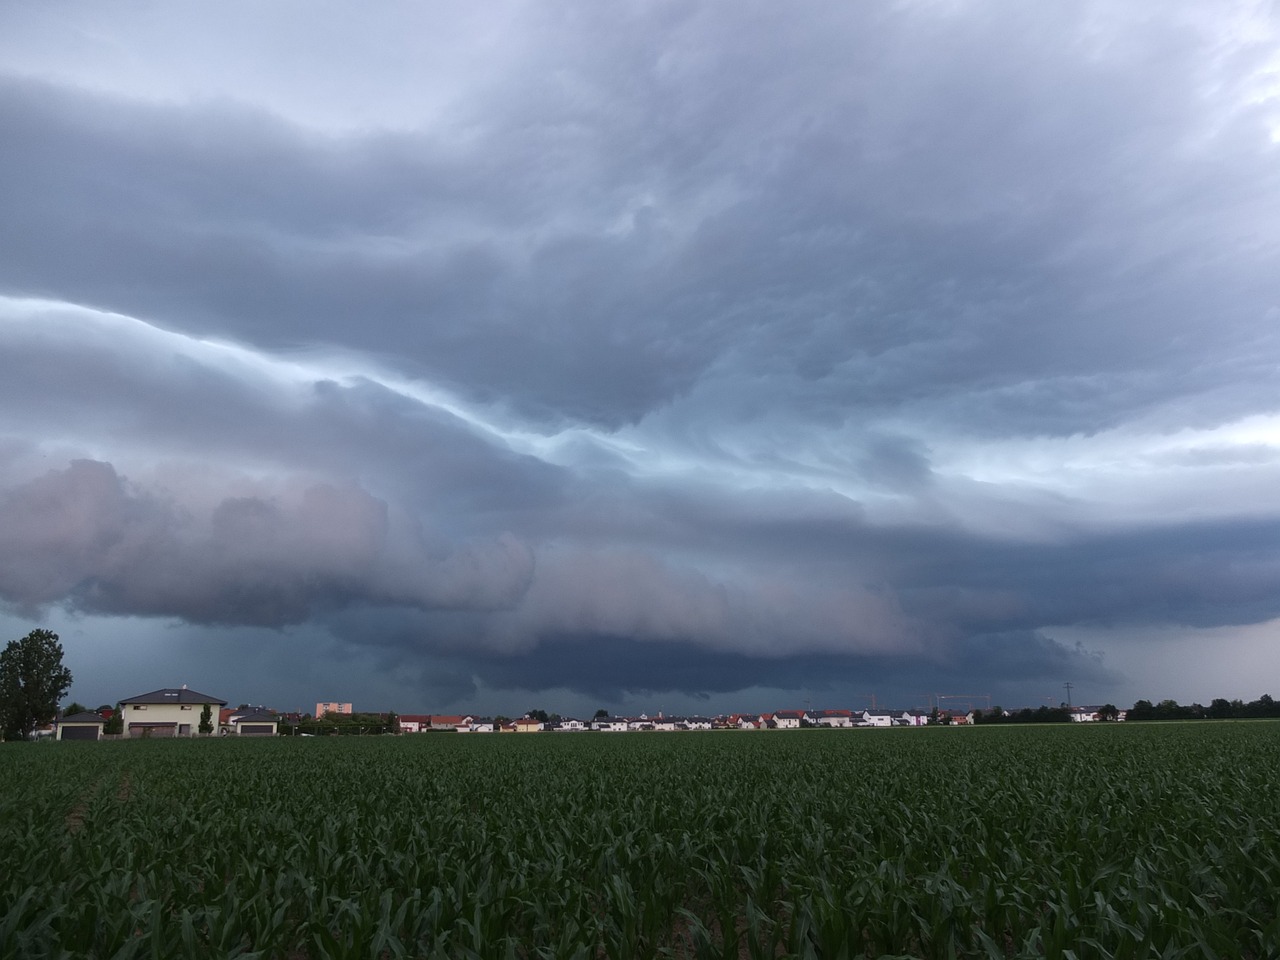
[0,0,1280,713]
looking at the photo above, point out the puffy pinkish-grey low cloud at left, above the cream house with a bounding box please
[0,461,532,626]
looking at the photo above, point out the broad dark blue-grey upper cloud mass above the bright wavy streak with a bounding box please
[0,0,1277,434]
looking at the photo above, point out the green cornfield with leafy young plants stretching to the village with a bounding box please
[0,722,1280,960]
